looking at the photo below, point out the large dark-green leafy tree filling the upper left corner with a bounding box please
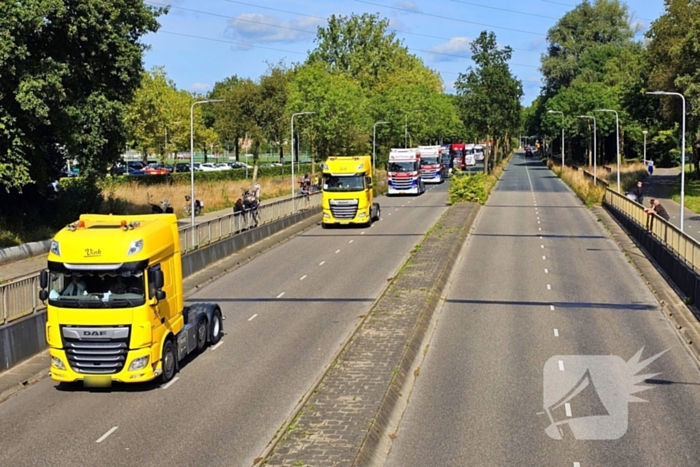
[0,0,166,189]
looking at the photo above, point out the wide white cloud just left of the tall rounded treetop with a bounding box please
[225,13,325,48]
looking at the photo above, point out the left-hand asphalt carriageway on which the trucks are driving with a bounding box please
[0,178,448,466]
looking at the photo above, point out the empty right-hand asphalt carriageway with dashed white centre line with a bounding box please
[386,155,700,467]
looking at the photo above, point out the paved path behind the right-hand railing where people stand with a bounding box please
[642,168,700,241]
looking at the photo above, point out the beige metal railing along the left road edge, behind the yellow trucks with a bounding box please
[0,193,321,325]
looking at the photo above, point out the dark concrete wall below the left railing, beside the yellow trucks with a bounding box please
[0,206,321,372]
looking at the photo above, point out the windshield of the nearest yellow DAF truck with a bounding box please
[49,271,146,308]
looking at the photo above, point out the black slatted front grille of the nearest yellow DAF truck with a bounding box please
[63,327,129,374]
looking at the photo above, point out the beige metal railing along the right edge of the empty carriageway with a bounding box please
[604,188,700,272]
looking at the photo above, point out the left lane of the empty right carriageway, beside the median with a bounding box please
[387,171,572,466]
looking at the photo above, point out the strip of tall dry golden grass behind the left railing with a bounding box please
[101,177,291,216]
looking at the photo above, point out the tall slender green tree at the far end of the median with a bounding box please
[455,31,523,170]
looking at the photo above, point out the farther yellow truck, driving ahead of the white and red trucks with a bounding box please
[321,156,381,228]
